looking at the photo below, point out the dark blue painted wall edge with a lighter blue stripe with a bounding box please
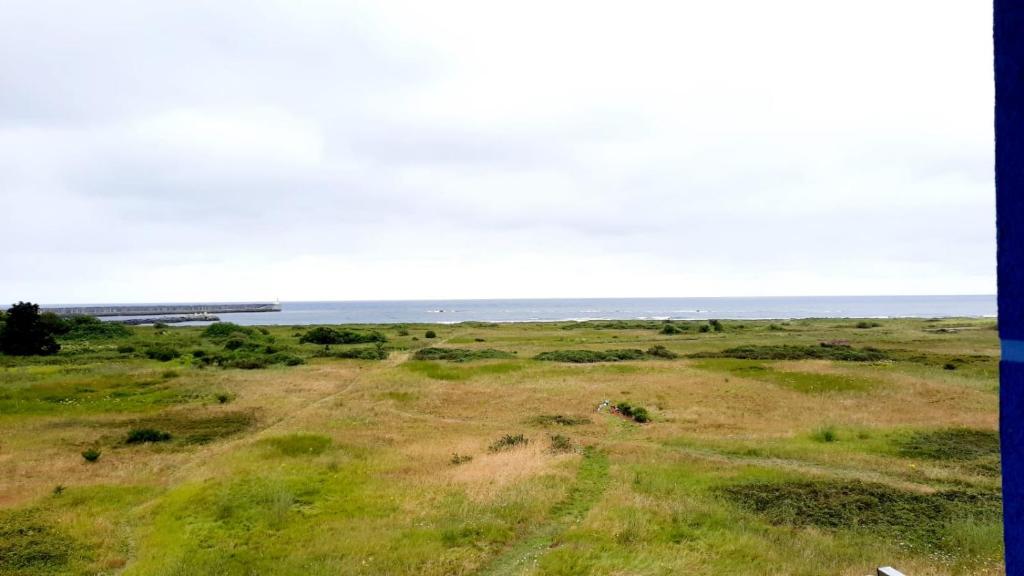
[993,0,1024,575]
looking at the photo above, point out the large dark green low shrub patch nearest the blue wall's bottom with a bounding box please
[720,480,1001,548]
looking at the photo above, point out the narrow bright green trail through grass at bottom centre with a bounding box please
[477,448,608,576]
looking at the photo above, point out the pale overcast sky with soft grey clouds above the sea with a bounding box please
[0,0,995,303]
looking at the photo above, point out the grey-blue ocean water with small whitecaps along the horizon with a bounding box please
[142,295,996,325]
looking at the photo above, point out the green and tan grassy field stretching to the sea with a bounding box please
[0,319,1002,576]
